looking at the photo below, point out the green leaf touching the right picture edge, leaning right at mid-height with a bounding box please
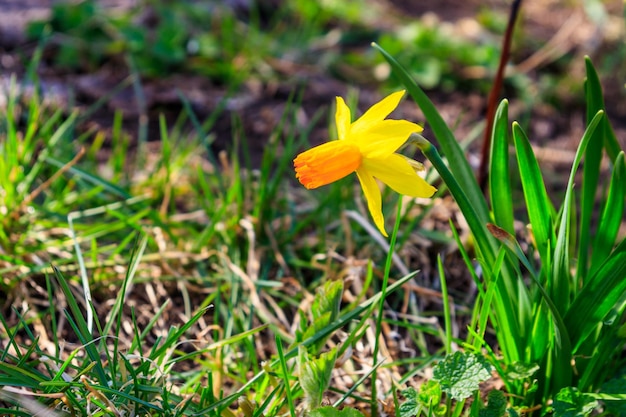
[580,152,626,274]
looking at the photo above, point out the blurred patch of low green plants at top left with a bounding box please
[28,0,263,83]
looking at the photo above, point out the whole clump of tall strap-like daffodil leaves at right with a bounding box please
[381,42,626,407]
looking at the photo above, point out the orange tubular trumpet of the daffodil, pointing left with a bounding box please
[293,140,362,190]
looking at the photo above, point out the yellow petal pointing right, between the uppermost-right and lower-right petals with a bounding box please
[356,120,423,158]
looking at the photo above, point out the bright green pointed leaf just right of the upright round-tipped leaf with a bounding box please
[513,122,555,279]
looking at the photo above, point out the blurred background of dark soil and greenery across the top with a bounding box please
[0,0,626,164]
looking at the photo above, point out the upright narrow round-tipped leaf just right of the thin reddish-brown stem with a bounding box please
[489,100,515,234]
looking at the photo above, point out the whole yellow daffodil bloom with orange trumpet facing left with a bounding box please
[293,91,436,236]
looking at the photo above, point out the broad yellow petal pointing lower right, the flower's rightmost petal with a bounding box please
[359,154,437,197]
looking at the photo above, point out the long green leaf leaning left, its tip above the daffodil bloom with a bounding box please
[372,44,489,224]
